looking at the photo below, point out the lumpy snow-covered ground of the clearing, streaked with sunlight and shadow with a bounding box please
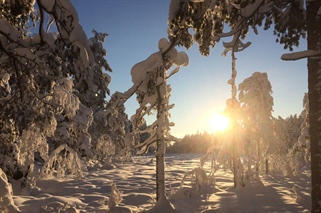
[14,154,311,213]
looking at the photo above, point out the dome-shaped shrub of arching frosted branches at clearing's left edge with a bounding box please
[40,144,85,178]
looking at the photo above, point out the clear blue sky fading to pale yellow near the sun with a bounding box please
[71,0,307,137]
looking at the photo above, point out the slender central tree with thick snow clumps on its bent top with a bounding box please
[131,38,188,211]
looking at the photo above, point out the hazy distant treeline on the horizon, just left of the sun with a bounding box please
[166,132,217,153]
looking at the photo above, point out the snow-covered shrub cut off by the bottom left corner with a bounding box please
[0,168,20,213]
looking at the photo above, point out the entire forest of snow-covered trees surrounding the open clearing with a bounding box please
[0,0,321,212]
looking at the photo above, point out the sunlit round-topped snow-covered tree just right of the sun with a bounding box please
[238,72,274,179]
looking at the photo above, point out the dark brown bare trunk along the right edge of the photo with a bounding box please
[306,0,321,213]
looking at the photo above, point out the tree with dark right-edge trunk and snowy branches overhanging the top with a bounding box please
[168,0,321,212]
